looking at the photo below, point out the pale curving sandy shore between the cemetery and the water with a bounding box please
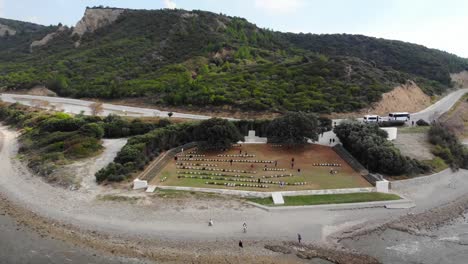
[0,124,468,263]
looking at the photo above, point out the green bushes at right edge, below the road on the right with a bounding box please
[429,123,468,169]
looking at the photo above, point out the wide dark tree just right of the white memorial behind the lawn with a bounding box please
[267,112,321,145]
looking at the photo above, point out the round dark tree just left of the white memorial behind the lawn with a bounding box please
[194,118,242,149]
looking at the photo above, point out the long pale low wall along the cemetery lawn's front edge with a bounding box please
[157,186,376,198]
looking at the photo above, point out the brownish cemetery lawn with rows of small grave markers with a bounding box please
[149,144,371,192]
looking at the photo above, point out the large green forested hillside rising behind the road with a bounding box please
[0,9,468,113]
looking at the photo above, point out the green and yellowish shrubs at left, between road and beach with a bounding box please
[0,103,169,185]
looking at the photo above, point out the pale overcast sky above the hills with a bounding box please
[0,0,468,58]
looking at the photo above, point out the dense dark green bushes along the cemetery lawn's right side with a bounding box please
[333,122,430,176]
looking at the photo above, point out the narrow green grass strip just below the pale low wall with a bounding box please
[248,192,401,206]
